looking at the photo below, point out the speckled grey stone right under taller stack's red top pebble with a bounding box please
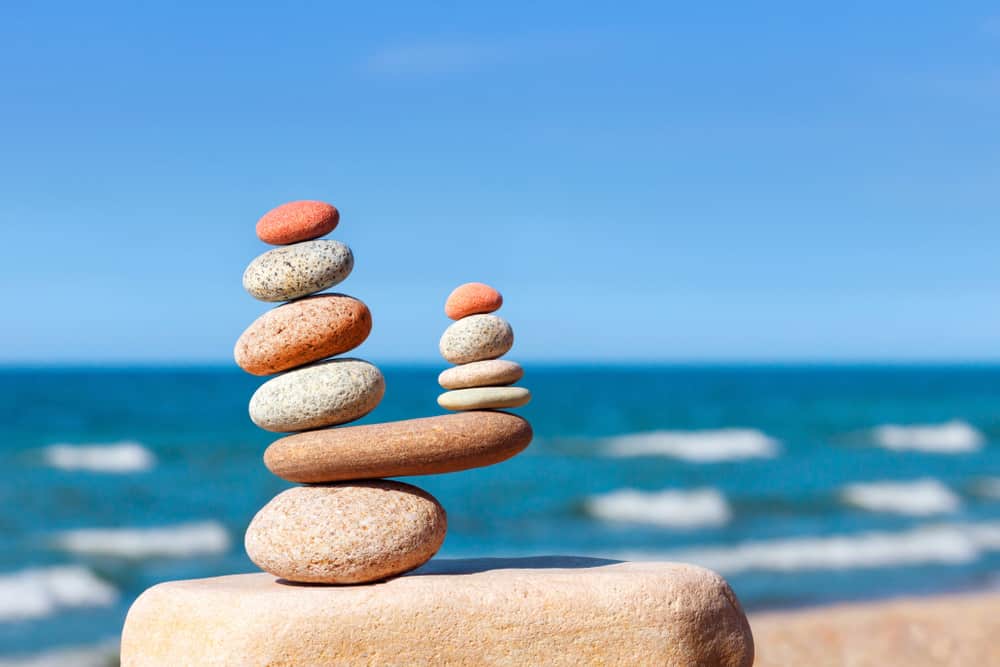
[243,239,354,301]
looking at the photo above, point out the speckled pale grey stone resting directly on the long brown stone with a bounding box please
[250,358,385,432]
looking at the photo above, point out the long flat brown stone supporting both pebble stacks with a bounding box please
[264,411,532,484]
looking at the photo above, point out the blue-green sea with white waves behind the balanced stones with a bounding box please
[0,364,1000,665]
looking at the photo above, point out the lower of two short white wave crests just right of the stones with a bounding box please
[586,489,731,528]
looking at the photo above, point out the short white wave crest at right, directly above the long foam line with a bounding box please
[840,479,962,516]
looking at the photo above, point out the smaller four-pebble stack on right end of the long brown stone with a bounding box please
[438,283,531,410]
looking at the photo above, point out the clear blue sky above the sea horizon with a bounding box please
[0,2,1000,363]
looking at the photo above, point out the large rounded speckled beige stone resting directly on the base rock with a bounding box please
[245,480,448,584]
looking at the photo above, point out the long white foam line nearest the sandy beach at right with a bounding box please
[612,522,1000,574]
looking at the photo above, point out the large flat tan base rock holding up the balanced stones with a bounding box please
[121,558,753,667]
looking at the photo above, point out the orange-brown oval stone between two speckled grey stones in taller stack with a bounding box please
[234,294,372,375]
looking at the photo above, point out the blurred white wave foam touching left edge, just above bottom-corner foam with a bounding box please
[0,565,118,621]
